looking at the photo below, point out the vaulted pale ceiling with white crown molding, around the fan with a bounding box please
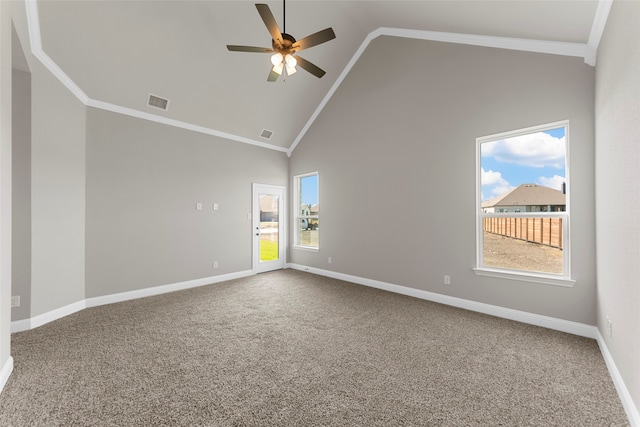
[27,0,608,151]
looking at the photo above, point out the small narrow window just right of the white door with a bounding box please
[293,172,320,249]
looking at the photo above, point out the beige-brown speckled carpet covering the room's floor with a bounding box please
[0,270,628,427]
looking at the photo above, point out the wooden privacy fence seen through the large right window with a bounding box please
[482,217,562,249]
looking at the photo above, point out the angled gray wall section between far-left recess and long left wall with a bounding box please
[31,58,86,317]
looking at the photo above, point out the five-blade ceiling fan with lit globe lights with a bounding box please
[227,1,336,82]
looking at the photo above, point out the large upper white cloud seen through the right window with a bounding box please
[482,132,566,169]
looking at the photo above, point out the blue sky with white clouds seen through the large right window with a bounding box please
[481,127,566,200]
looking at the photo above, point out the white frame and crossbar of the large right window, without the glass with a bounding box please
[473,120,575,287]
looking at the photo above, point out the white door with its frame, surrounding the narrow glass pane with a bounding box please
[251,182,287,274]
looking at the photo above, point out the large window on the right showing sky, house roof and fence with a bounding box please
[475,122,573,286]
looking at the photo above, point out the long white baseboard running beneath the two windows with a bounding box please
[287,264,598,339]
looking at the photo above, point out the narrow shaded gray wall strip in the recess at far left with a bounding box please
[11,69,31,321]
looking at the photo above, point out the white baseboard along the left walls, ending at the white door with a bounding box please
[11,270,253,333]
